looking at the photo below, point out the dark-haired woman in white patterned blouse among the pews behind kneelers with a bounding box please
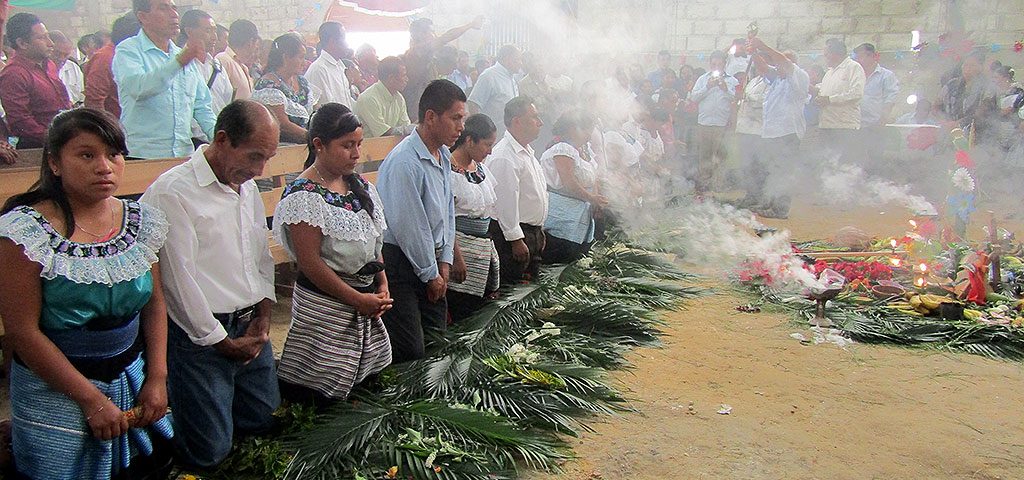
[252,34,319,143]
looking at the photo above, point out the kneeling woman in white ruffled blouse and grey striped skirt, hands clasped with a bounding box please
[273,103,392,402]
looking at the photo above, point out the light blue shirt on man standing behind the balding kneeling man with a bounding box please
[112,32,217,159]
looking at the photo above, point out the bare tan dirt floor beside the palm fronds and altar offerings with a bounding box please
[526,195,1024,480]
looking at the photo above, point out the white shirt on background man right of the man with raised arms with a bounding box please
[818,57,865,130]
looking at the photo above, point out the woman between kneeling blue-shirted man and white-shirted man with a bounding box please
[447,114,500,321]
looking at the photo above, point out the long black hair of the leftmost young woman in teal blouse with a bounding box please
[0,107,128,238]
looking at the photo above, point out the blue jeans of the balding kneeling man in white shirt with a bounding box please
[167,315,281,468]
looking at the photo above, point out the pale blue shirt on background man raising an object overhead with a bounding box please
[762,64,811,138]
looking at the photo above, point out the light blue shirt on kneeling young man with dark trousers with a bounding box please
[377,130,455,282]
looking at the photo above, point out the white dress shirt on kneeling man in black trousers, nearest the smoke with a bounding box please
[484,132,548,242]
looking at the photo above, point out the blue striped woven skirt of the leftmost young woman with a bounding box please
[10,355,173,480]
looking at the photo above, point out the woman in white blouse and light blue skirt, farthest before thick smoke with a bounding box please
[541,111,608,263]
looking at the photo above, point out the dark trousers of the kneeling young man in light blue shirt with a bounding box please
[382,244,447,363]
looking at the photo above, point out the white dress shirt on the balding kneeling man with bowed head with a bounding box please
[141,145,276,346]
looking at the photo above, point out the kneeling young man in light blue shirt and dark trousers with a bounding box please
[377,80,466,363]
